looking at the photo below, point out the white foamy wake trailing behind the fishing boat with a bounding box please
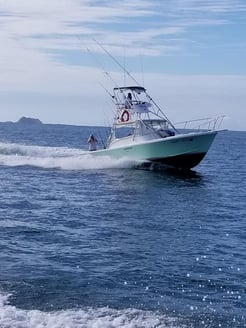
[0,142,135,170]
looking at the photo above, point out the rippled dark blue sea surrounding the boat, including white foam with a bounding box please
[0,123,246,328]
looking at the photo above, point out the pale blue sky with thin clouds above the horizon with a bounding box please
[0,0,246,131]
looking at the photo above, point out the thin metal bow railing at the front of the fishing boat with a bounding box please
[174,115,225,131]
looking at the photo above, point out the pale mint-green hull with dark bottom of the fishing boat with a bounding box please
[87,131,217,169]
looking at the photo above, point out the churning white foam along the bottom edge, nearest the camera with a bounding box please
[0,295,180,328]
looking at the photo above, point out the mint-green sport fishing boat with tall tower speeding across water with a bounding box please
[87,85,223,169]
